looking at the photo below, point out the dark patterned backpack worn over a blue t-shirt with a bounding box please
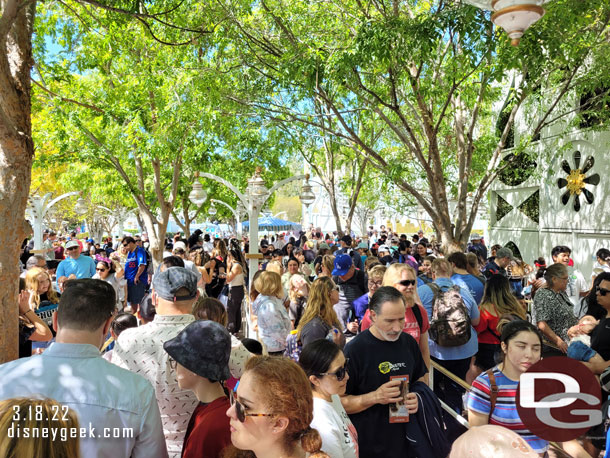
[427,283,472,347]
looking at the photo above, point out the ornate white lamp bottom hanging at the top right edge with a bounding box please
[464,0,550,46]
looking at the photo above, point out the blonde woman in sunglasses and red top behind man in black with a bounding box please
[361,264,430,379]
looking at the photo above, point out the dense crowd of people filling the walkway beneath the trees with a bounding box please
[0,226,610,458]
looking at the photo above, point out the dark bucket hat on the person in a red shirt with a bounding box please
[163,320,231,381]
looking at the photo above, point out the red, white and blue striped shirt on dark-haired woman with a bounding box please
[468,366,549,453]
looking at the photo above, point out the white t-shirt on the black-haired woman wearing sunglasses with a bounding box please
[311,394,358,458]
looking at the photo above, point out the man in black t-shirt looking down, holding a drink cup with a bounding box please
[341,286,428,458]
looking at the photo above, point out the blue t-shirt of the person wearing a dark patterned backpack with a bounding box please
[417,278,479,360]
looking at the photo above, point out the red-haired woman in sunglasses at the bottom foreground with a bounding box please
[223,356,330,458]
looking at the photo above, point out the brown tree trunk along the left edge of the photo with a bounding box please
[0,0,36,363]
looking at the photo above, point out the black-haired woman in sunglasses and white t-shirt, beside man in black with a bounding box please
[299,339,358,458]
